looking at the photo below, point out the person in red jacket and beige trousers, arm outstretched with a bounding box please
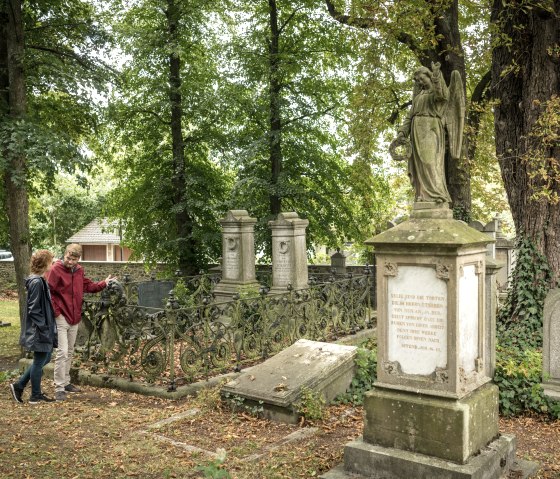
[48,243,113,401]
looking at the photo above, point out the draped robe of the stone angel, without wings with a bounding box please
[399,72,451,203]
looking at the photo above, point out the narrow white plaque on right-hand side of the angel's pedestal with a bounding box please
[459,265,479,373]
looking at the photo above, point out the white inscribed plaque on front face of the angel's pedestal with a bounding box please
[387,265,447,375]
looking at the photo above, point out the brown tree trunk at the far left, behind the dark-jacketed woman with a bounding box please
[0,0,31,327]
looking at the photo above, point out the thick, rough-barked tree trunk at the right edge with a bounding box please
[492,0,560,280]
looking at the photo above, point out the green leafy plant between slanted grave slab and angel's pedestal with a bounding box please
[336,341,377,405]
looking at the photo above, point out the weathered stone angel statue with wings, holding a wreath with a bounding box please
[390,63,465,206]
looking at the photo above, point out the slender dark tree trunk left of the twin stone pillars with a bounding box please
[165,0,199,275]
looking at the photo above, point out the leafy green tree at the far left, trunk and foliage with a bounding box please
[0,0,112,324]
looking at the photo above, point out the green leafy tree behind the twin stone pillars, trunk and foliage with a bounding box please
[223,0,392,255]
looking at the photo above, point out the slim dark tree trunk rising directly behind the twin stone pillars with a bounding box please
[268,0,282,217]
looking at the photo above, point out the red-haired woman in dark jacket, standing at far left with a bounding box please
[10,250,57,404]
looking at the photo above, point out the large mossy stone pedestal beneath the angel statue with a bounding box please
[323,203,515,479]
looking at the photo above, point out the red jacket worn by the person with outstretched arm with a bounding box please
[48,260,107,324]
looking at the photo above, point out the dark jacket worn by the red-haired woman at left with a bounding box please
[19,274,58,353]
